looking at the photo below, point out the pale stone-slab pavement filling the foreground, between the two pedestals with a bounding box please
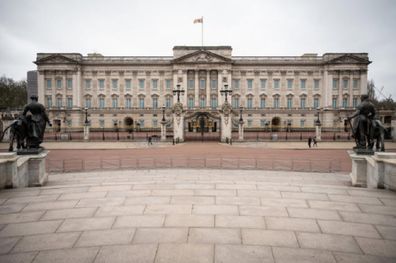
[0,169,396,263]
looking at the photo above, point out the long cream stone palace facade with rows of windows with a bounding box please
[34,46,371,134]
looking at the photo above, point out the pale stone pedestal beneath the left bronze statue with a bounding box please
[0,151,48,188]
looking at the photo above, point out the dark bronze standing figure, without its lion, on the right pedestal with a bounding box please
[348,95,376,154]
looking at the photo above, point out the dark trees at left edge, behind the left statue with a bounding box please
[0,76,27,110]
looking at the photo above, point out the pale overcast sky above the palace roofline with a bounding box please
[0,0,396,99]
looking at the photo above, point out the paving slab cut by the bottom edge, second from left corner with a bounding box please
[34,248,99,263]
